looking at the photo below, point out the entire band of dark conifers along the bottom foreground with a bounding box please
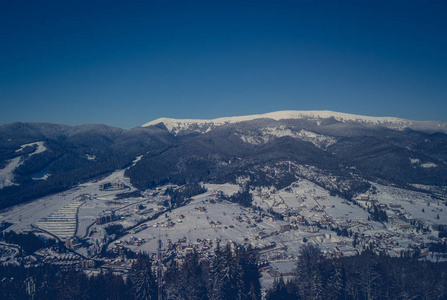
[0,244,447,300]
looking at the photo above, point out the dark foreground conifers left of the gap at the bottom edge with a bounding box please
[0,244,261,300]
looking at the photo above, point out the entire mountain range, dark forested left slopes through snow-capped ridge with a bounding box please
[0,111,447,208]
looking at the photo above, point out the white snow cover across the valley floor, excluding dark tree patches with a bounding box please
[0,157,447,274]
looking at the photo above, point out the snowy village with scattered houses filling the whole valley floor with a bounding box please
[0,166,447,284]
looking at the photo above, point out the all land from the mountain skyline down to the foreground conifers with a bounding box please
[0,112,447,296]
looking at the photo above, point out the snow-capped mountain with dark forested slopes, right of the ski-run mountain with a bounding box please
[136,111,447,197]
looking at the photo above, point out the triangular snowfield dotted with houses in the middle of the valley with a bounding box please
[112,184,266,252]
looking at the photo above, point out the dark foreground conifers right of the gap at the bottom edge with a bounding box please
[266,245,447,300]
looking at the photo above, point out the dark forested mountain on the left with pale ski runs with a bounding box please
[0,123,176,208]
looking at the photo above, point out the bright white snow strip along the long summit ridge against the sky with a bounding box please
[142,110,447,134]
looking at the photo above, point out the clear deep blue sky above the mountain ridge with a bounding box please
[0,0,447,128]
